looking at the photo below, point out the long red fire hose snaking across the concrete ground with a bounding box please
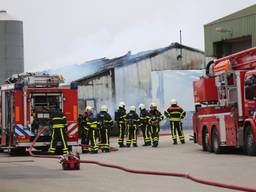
[29,129,256,192]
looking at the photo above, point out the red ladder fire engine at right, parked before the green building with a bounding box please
[193,48,256,155]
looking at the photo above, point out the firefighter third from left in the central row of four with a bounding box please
[139,104,151,146]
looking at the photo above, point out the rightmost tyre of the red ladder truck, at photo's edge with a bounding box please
[245,127,256,156]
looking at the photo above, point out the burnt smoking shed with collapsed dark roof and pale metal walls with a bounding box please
[77,43,205,123]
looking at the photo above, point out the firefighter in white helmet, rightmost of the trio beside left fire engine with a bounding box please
[97,105,113,152]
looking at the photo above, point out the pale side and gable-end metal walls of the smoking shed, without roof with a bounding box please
[78,49,204,118]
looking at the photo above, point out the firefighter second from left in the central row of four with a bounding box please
[126,105,139,147]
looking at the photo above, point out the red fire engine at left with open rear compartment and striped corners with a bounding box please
[0,73,78,154]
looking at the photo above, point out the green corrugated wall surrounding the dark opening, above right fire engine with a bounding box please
[204,13,256,56]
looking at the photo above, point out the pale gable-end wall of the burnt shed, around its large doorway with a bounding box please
[115,49,205,108]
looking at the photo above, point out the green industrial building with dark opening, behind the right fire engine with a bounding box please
[204,5,256,58]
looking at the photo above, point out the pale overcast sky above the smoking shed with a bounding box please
[0,0,255,71]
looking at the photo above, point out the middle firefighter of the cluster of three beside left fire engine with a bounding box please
[85,106,98,153]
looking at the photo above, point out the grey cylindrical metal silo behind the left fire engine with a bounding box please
[0,10,24,84]
